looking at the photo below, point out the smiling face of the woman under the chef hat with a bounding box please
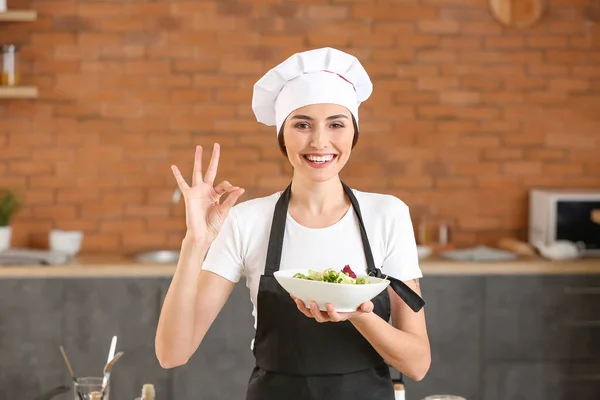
[283,104,355,182]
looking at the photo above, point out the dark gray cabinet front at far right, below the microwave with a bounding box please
[484,275,600,361]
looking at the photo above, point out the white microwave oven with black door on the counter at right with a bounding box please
[529,188,600,257]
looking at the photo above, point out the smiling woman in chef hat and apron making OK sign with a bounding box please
[156,48,430,400]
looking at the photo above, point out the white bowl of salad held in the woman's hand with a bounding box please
[273,269,390,312]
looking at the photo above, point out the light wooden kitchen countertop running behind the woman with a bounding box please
[0,255,600,279]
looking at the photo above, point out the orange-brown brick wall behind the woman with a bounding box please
[0,0,600,252]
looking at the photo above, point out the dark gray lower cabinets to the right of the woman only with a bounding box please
[406,275,600,400]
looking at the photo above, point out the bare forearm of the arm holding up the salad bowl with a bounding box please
[350,312,431,381]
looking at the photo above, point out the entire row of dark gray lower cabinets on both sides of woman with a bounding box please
[0,275,600,400]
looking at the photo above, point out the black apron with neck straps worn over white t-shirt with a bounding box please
[246,183,424,400]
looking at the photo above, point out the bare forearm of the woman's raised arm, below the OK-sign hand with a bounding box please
[155,236,208,368]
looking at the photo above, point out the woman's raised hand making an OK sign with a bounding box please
[171,143,244,246]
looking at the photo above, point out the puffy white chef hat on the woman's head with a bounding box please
[252,47,373,134]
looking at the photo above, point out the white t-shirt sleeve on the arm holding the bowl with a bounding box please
[381,199,423,281]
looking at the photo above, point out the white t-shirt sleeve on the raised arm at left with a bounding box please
[202,207,244,283]
